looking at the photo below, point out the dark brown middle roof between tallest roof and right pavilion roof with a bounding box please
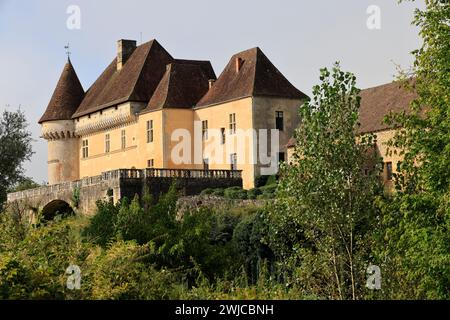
[143,60,215,112]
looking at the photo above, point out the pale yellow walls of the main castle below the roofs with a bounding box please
[43,97,301,189]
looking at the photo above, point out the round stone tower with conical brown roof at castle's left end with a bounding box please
[39,59,84,184]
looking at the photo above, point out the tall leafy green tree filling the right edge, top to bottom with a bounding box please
[377,0,450,299]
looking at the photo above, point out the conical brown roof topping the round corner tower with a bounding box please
[39,59,84,123]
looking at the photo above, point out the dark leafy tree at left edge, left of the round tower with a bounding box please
[0,110,33,209]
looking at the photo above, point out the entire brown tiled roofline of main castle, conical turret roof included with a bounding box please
[40,40,306,122]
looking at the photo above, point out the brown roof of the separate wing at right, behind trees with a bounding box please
[359,81,417,133]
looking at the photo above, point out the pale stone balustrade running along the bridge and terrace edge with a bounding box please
[8,168,242,202]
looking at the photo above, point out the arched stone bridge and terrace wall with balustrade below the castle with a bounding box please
[8,169,242,220]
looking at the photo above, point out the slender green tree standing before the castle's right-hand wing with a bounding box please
[267,64,380,299]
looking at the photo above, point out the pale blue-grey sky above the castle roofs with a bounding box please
[0,0,422,182]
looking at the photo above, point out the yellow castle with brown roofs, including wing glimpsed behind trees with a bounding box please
[39,40,413,189]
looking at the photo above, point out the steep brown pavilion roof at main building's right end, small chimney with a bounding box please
[197,48,306,107]
